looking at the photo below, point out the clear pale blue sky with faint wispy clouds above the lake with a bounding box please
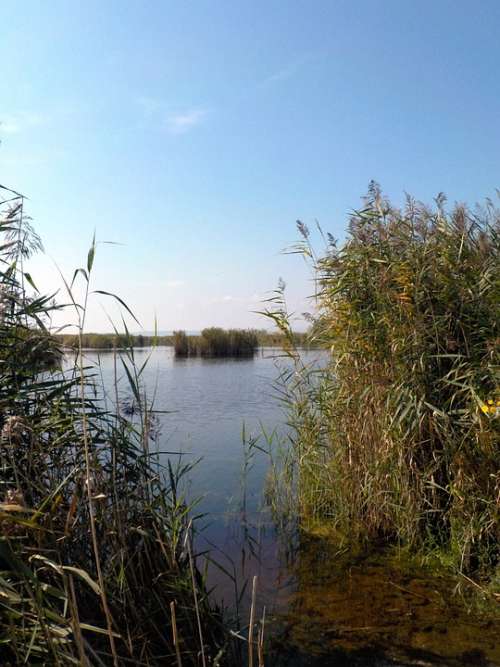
[0,0,500,331]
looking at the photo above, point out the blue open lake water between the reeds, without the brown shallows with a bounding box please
[85,347,300,606]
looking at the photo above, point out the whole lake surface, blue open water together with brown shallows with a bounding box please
[80,347,500,667]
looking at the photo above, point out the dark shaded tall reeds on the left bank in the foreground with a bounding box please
[0,188,242,666]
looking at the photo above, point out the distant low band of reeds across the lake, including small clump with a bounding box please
[56,327,310,356]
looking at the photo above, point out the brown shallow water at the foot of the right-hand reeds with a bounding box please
[268,536,500,666]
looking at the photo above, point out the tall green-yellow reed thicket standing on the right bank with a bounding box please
[267,184,500,575]
